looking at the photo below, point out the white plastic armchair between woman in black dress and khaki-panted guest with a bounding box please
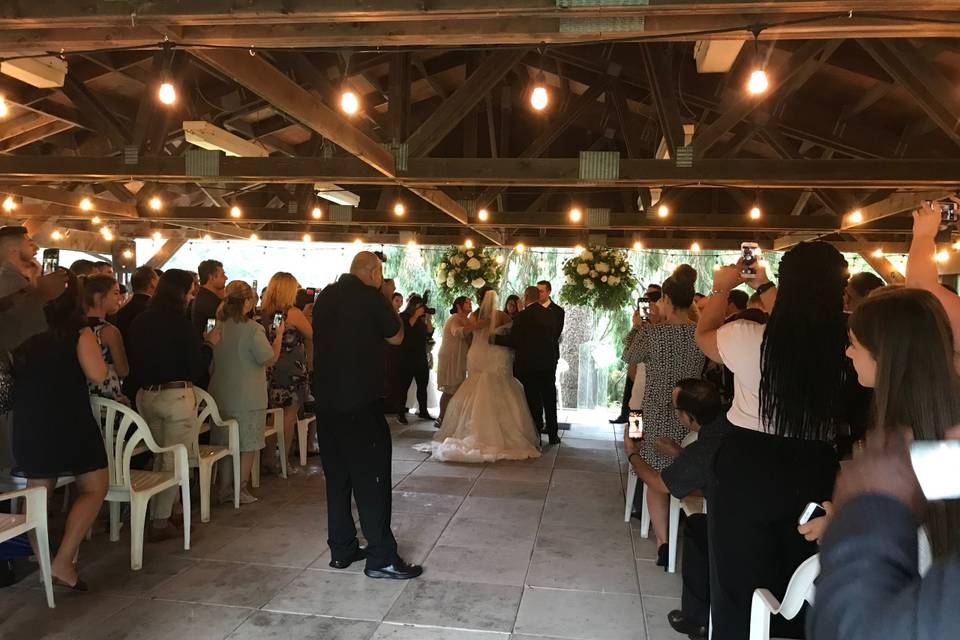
[90,396,190,571]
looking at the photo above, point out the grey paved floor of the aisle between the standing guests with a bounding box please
[0,416,681,640]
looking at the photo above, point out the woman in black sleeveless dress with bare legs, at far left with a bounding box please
[13,272,109,591]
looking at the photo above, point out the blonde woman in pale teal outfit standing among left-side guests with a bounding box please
[210,280,283,504]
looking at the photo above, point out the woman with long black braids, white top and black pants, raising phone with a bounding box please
[697,242,852,640]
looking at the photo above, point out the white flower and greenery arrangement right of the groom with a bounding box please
[560,247,637,310]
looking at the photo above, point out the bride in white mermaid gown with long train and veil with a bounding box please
[416,291,540,462]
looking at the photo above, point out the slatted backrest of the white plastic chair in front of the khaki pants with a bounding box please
[90,396,160,490]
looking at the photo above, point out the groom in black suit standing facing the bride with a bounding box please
[494,286,563,444]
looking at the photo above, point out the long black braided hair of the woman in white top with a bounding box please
[760,242,848,440]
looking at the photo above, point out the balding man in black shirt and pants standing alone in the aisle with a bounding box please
[313,251,423,580]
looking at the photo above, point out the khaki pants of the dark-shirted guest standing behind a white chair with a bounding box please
[137,388,197,520]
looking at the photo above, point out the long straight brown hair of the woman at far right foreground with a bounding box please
[850,289,960,558]
